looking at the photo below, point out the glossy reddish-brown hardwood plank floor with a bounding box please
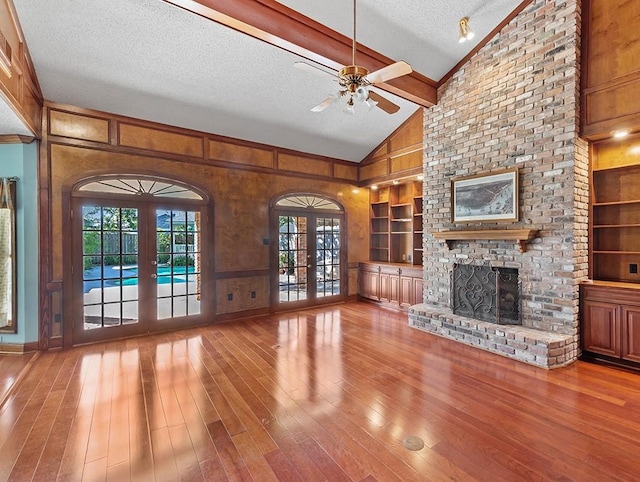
[0,303,640,481]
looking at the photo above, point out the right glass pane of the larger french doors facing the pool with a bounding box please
[154,209,202,319]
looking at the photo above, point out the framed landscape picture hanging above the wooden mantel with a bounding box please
[451,168,519,223]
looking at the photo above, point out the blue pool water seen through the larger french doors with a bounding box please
[84,266,195,293]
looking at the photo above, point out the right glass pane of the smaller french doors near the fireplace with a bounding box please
[316,218,340,298]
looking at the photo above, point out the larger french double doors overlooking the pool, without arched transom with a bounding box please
[72,196,210,344]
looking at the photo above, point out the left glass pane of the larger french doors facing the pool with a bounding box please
[82,206,139,330]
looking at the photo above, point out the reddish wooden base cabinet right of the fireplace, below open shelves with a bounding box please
[580,281,640,368]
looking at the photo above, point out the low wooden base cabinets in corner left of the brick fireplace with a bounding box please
[358,263,423,309]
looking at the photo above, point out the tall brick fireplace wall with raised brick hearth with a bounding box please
[409,0,588,368]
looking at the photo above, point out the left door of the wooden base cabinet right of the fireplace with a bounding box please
[582,300,620,357]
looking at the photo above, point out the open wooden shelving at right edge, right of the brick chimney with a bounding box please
[590,135,640,283]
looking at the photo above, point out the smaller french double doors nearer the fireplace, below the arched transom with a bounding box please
[272,205,346,310]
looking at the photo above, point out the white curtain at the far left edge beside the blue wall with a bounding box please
[0,178,14,328]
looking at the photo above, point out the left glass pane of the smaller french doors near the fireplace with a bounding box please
[278,216,310,303]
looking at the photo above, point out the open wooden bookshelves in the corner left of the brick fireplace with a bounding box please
[369,181,422,266]
